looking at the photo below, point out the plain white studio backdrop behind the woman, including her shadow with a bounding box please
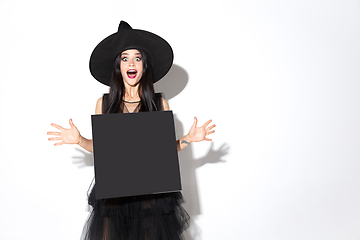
[0,0,360,240]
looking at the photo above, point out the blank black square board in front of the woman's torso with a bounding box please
[91,111,181,199]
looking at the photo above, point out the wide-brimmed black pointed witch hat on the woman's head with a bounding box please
[90,21,174,86]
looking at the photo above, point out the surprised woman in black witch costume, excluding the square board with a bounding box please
[48,21,215,240]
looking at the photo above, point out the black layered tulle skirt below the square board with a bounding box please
[82,181,189,240]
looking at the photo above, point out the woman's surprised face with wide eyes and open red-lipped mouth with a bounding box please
[120,49,143,86]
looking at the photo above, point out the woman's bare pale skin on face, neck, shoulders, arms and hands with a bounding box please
[47,49,215,153]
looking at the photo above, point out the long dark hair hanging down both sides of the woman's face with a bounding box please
[103,50,159,113]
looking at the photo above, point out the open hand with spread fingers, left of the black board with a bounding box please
[47,119,81,146]
